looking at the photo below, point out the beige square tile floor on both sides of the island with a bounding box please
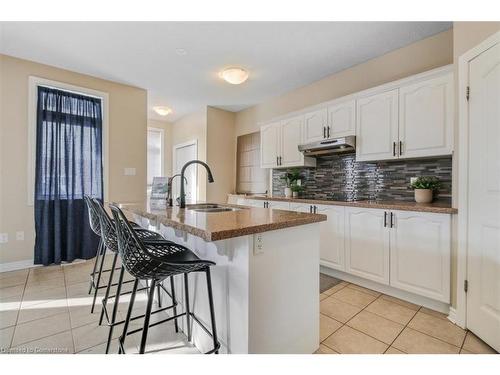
[0,257,494,354]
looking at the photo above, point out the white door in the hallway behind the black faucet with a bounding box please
[172,141,198,203]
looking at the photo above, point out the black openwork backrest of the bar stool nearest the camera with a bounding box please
[109,204,161,279]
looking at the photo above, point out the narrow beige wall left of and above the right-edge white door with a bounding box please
[451,22,500,306]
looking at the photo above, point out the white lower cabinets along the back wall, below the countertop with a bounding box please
[247,199,451,303]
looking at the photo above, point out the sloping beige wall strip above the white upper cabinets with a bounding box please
[236,30,453,135]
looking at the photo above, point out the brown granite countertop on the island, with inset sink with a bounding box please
[120,203,327,242]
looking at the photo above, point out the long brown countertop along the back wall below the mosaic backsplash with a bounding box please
[238,195,458,214]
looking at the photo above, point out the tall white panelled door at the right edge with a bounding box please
[467,44,500,351]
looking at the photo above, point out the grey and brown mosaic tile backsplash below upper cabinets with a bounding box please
[273,154,452,201]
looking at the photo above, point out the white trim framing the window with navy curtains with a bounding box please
[27,76,109,206]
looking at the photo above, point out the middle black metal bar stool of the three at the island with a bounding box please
[92,199,177,354]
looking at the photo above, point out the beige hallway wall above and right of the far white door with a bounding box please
[172,108,207,201]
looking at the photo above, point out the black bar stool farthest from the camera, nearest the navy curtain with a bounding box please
[84,195,141,313]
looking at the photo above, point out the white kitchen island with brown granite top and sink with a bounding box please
[121,204,326,354]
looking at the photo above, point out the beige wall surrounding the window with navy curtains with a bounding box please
[0,55,147,263]
